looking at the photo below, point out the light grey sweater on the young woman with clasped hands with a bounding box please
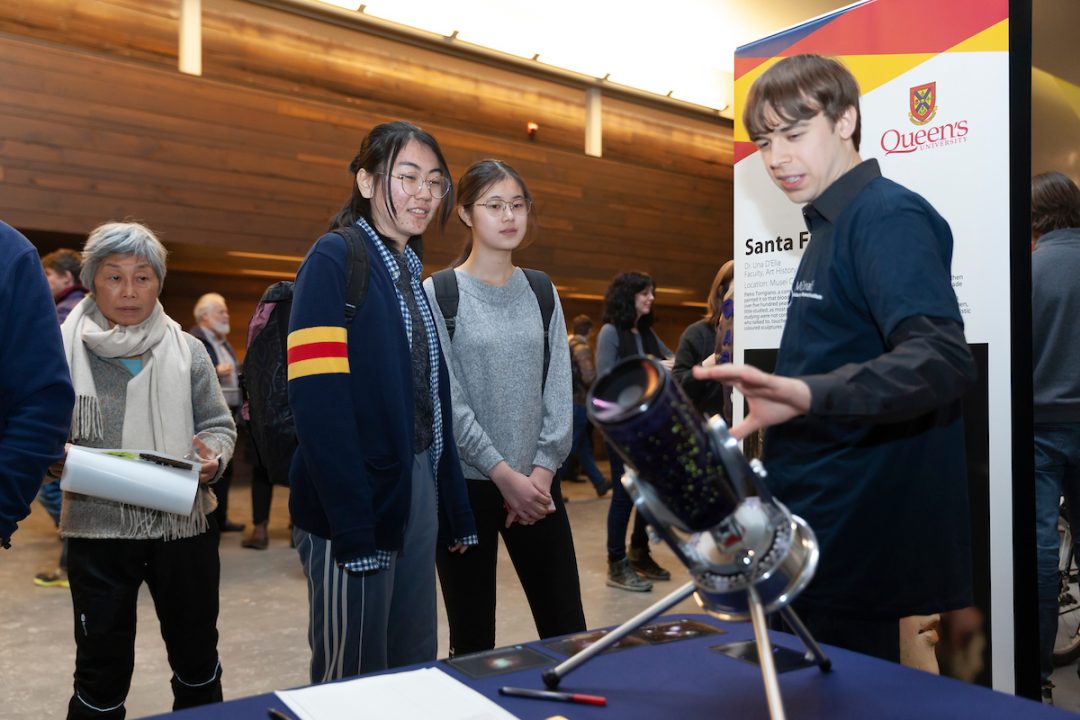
[423,268,573,479]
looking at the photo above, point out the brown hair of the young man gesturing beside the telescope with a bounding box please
[743,55,862,150]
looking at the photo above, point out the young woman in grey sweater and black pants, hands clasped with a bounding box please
[424,160,585,655]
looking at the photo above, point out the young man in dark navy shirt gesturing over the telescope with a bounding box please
[694,55,975,669]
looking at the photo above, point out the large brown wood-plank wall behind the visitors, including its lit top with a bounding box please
[0,0,731,347]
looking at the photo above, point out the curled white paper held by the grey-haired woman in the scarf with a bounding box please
[60,445,200,515]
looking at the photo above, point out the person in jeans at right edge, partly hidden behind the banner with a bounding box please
[1031,173,1080,701]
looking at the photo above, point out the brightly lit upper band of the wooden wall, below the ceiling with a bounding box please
[0,0,731,179]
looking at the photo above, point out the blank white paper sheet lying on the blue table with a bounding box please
[274,667,516,720]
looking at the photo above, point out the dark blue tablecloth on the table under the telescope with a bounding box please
[145,614,1075,720]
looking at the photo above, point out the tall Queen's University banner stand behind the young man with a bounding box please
[734,0,1038,696]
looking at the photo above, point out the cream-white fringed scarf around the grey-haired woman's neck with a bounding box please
[60,296,194,458]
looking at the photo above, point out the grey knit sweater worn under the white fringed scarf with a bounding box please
[60,332,237,540]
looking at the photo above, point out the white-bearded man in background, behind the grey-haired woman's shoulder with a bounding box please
[188,293,244,532]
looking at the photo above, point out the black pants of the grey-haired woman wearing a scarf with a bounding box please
[67,520,221,720]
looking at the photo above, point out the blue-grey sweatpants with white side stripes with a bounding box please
[293,451,438,683]
